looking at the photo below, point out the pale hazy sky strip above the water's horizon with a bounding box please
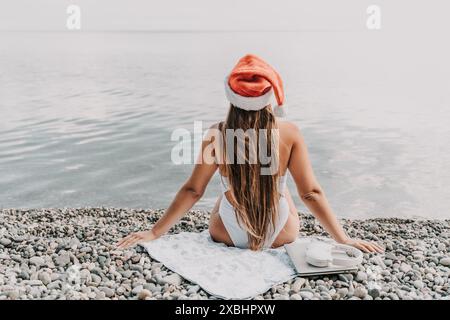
[0,0,450,31]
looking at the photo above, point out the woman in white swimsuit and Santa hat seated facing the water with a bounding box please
[117,55,383,252]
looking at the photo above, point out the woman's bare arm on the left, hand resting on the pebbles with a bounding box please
[117,131,218,249]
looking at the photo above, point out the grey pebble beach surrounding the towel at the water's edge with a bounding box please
[0,208,450,300]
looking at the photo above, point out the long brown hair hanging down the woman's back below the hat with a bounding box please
[221,105,279,250]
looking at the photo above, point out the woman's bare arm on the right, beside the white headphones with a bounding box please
[288,124,383,252]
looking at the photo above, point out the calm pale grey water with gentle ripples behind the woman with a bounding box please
[0,32,450,218]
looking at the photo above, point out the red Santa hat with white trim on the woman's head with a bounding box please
[225,54,285,116]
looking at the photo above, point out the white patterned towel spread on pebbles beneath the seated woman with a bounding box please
[142,230,296,299]
